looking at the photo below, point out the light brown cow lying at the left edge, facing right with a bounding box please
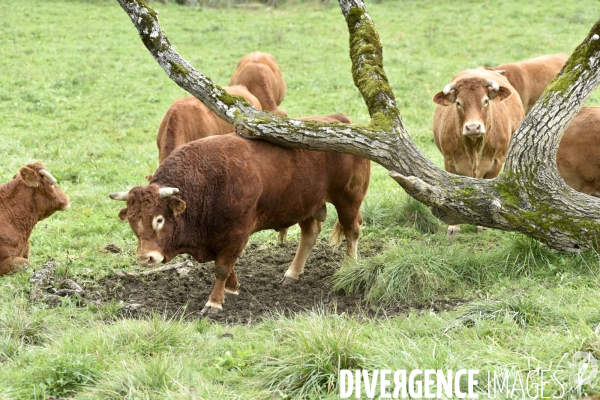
[0,162,71,275]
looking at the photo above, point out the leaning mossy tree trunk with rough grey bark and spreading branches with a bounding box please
[117,0,600,251]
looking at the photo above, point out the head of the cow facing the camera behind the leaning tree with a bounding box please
[433,77,512,138]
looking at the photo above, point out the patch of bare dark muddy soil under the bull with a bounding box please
[84,240,454,324]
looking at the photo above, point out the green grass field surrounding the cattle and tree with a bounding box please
[0,0,600,399]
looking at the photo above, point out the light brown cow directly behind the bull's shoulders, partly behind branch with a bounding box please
[156,85,262,164]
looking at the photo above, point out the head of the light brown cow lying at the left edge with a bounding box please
[15,162,71,221]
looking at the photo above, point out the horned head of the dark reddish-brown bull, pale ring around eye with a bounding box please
[110,184,186,267]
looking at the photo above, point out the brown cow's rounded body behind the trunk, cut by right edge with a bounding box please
[556,107,600,197]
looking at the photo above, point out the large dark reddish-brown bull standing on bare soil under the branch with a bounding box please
[110,134,370,313]
